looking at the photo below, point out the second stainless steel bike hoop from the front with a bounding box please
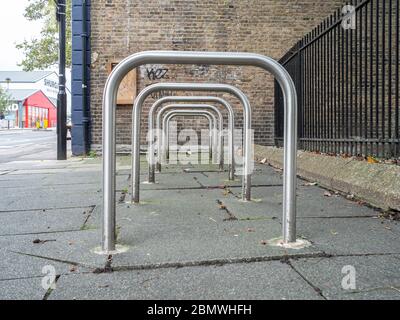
[131,83,252,203]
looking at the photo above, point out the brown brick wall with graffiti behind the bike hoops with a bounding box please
[85,0,343,150]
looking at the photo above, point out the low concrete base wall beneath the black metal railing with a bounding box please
[254,145,400,211]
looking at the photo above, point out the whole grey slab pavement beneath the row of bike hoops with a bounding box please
[0,136,400,300]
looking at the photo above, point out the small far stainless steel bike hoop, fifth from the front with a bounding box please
[162,109,222,165]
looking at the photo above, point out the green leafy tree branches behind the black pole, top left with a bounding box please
[16,0,72,71]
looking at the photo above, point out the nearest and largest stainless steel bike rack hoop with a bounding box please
[102,51,297,254]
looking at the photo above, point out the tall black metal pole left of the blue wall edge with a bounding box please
[57,0,67,160]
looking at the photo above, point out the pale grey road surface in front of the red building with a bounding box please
[0,130,69,163]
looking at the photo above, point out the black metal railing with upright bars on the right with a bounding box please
[275,0,400,158]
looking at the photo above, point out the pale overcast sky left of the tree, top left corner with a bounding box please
[0,0,41,70]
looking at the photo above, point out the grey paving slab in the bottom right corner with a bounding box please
[291,255,400,300]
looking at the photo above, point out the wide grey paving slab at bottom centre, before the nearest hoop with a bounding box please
[49,262,321,300]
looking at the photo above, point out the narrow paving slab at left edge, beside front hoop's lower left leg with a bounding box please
[0,207,93,236]
